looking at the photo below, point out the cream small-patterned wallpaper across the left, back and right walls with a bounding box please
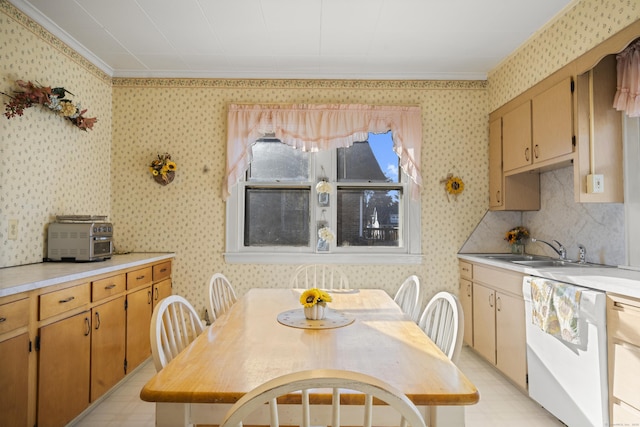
[0,0,640,320]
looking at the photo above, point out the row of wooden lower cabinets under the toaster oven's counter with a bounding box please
[0,259,172,427]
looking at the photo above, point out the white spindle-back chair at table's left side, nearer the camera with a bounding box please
[150,295,204,372]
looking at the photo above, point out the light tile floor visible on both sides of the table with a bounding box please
[71,347,564,427]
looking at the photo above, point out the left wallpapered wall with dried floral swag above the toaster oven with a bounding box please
[0,1,111,267]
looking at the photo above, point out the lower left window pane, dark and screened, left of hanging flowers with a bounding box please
[244,188,310,246]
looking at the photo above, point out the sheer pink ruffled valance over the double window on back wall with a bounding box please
[223,104,422,200]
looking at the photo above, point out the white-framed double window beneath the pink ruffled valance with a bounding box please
[225,132,420,263]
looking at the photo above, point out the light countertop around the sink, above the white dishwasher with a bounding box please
[458,254,640,298]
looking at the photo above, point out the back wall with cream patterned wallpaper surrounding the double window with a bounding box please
[112,79,488,314]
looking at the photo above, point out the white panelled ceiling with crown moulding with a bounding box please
[9,0,577,80]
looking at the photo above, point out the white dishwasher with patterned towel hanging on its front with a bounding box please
[522,276,609,427]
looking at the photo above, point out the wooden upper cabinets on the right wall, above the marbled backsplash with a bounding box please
[489,21,640,210]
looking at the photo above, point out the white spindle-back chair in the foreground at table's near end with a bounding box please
[220,369,425,427]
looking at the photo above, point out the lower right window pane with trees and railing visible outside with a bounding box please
[338,188,402,247]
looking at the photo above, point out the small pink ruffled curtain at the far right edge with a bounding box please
[613,40,640,117]
